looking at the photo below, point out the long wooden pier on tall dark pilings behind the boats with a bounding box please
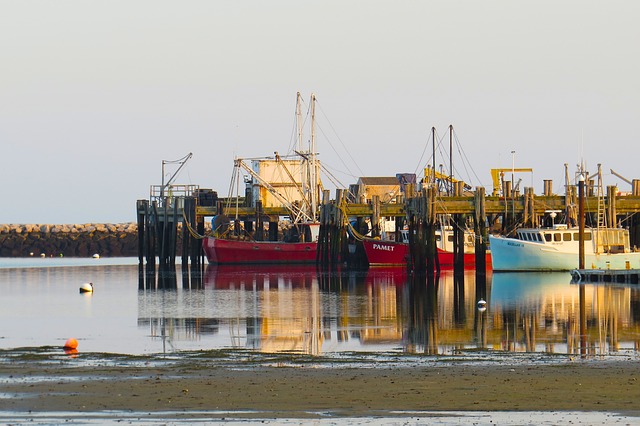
[136,175,640,288]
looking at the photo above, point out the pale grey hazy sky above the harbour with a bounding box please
[0,0,640,224]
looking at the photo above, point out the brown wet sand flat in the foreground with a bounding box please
[0,353,640,418]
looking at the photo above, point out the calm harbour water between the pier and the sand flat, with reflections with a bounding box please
[0,258,640,359]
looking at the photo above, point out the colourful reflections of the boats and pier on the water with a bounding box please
[138,265,640,356]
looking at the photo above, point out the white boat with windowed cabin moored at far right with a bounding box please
[489,225,640,271]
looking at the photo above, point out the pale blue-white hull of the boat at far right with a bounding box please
[489,235,640,271]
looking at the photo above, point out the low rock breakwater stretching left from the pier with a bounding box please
[0,222,138,257]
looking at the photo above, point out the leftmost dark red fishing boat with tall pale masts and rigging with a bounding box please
[202,93,322,264]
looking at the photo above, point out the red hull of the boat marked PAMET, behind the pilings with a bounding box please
[362,239,491,268]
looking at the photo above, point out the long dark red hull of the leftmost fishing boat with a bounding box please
[202,237,317,264]
